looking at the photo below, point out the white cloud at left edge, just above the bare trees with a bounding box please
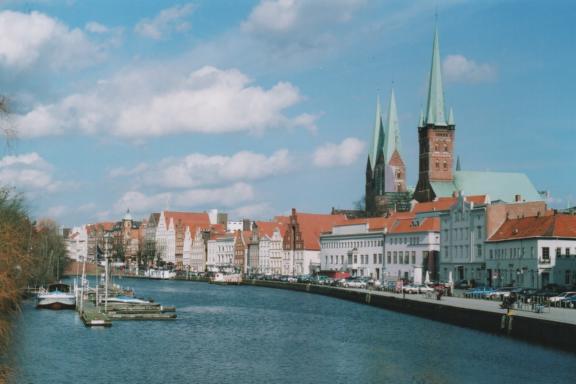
[0,152,63,193]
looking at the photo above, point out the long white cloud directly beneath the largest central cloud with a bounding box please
[110,149,294,188]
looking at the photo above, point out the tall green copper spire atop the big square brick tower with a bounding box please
[424,27,446,126]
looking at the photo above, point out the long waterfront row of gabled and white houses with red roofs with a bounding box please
[68,195,576,287]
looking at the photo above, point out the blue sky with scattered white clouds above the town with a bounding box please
[0,0,576,226]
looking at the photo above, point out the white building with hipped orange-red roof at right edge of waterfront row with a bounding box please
[486,214,576,288]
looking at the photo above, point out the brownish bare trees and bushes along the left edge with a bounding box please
[0,187,68,383]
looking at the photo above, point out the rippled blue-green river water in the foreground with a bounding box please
[6,279,576,384]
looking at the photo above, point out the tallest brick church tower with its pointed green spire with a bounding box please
[414,28,456,202]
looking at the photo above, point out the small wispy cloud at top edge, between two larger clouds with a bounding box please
[134,4,194,40]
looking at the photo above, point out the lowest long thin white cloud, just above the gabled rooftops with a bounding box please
[114,183,255,214]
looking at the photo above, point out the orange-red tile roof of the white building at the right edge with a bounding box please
[488,215,576,241]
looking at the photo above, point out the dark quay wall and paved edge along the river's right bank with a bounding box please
[244,280,576,353]
